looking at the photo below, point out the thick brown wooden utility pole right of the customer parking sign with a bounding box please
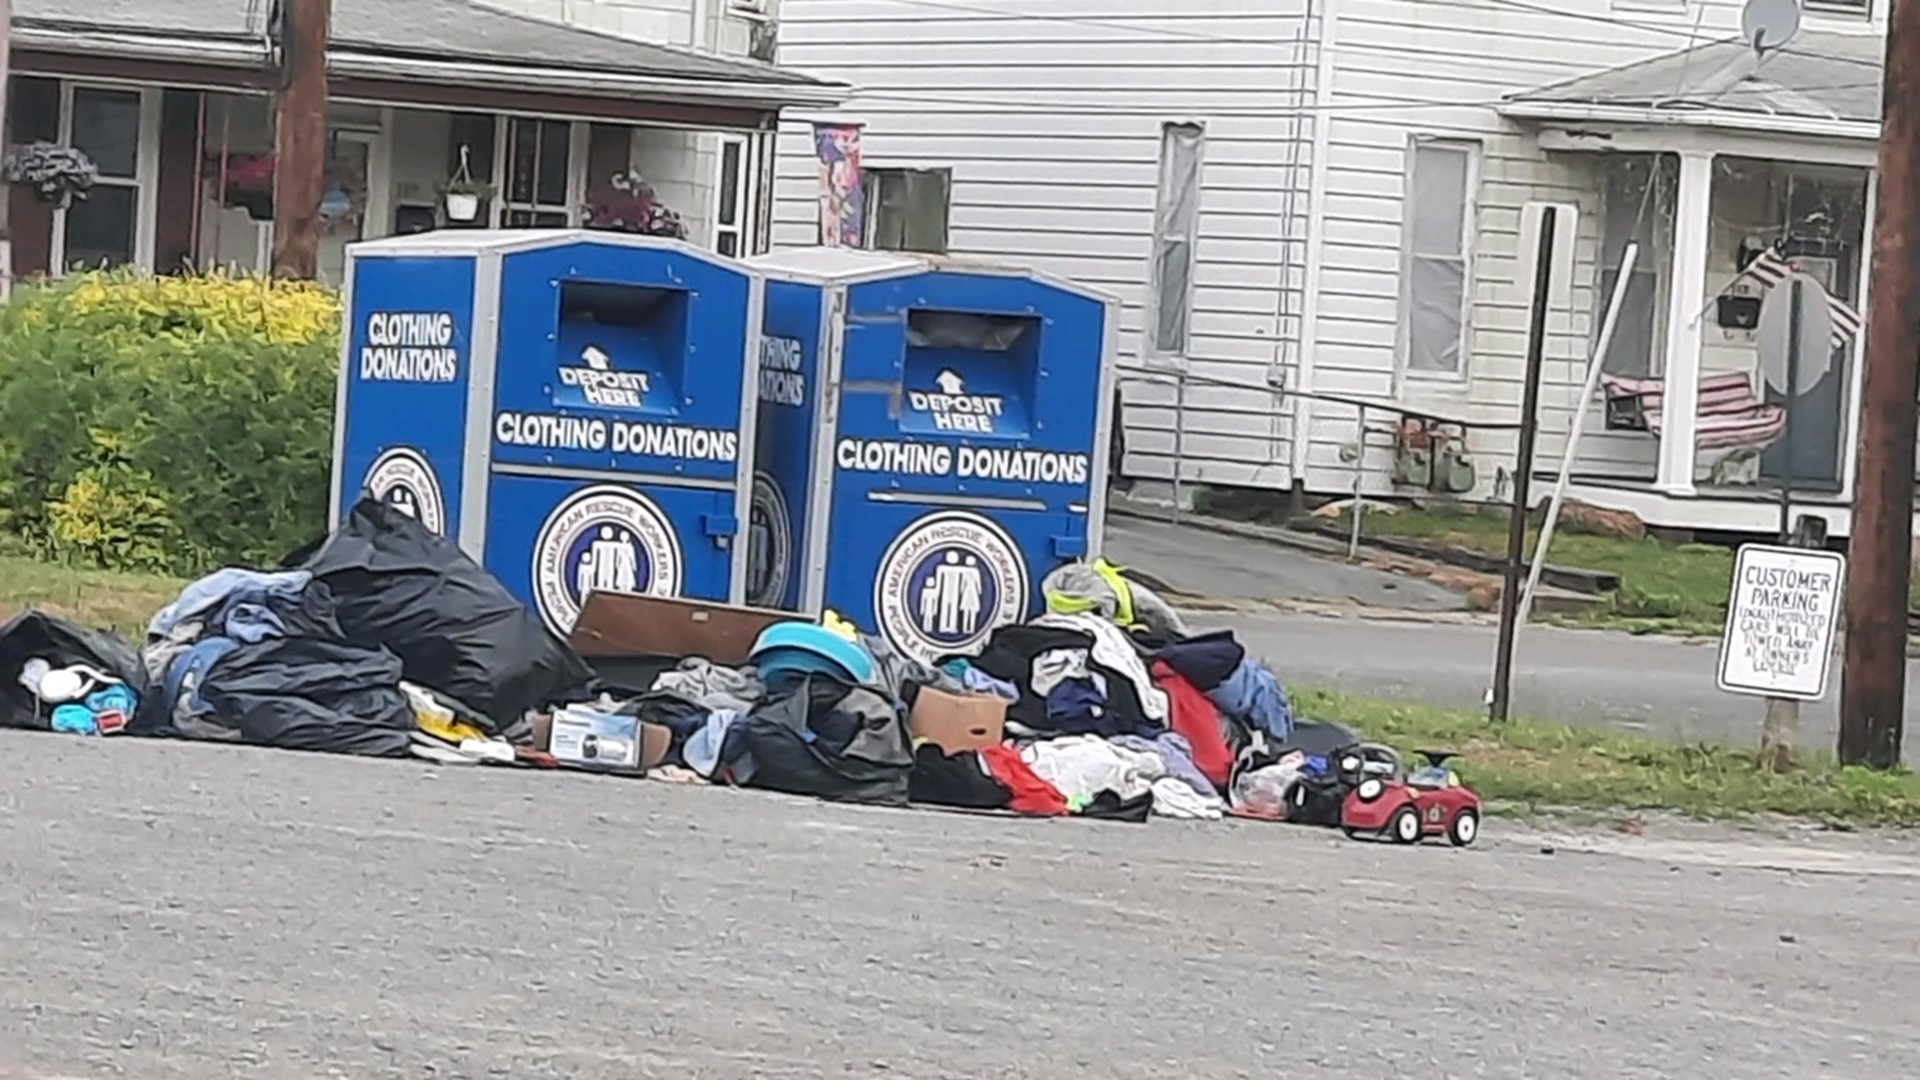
[1839,4,1920,769]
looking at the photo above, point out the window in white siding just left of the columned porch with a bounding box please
[1400,140,1478,377]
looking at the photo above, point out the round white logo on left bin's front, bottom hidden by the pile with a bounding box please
[534,486,684,638]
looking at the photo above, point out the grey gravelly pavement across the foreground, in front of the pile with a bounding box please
[0,734,1920,1080]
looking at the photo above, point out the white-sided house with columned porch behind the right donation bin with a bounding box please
[772,0,1887,534]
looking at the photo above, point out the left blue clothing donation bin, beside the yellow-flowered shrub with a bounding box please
[332,231,760,636]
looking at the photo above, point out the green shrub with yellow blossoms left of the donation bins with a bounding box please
[0,273,340,575]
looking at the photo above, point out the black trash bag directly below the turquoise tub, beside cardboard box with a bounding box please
[743,675,914,807]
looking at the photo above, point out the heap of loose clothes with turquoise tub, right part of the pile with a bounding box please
[612,549,1357,821]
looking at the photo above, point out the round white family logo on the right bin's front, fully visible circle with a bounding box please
[874,511,1027,663]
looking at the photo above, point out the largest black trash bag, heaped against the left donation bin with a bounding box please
[300,498,597,734]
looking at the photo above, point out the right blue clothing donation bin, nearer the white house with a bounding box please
[747,248,1117,661]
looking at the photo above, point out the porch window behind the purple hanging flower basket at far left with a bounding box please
[54,83,159,271]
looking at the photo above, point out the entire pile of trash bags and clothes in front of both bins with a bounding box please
[0,500,1357,821]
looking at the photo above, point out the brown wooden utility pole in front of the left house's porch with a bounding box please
[273,0,334,281]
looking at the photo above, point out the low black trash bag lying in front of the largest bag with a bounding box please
[200,638,415,757]
